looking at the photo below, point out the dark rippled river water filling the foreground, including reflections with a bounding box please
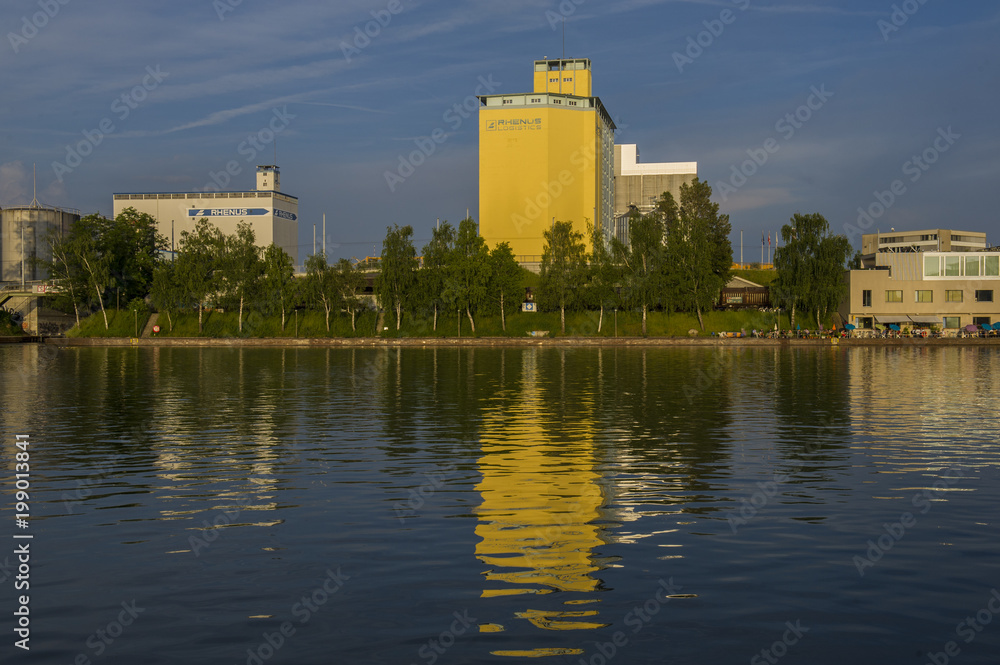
[0,345,1000,665]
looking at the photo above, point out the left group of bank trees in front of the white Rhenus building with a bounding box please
[41,208,365,332]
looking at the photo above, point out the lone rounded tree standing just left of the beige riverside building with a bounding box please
[771,213,852,327]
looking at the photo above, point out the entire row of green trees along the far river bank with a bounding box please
[42,183,851,335]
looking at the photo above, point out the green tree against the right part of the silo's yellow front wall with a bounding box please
[539,222,587,335]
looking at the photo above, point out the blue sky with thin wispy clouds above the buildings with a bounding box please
[0,0,1000,261]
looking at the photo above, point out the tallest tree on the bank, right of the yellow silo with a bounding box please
[658,178,733,330]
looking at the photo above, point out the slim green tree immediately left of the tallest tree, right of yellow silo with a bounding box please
[611,209,669,335]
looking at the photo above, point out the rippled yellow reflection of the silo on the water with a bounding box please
[476,349,606,657]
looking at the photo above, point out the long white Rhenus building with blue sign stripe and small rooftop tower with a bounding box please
[114,165,299,265]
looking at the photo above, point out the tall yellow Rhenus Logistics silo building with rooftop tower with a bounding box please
[479,58,615,263]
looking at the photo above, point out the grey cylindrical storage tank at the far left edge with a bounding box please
[0,206,80,282]
